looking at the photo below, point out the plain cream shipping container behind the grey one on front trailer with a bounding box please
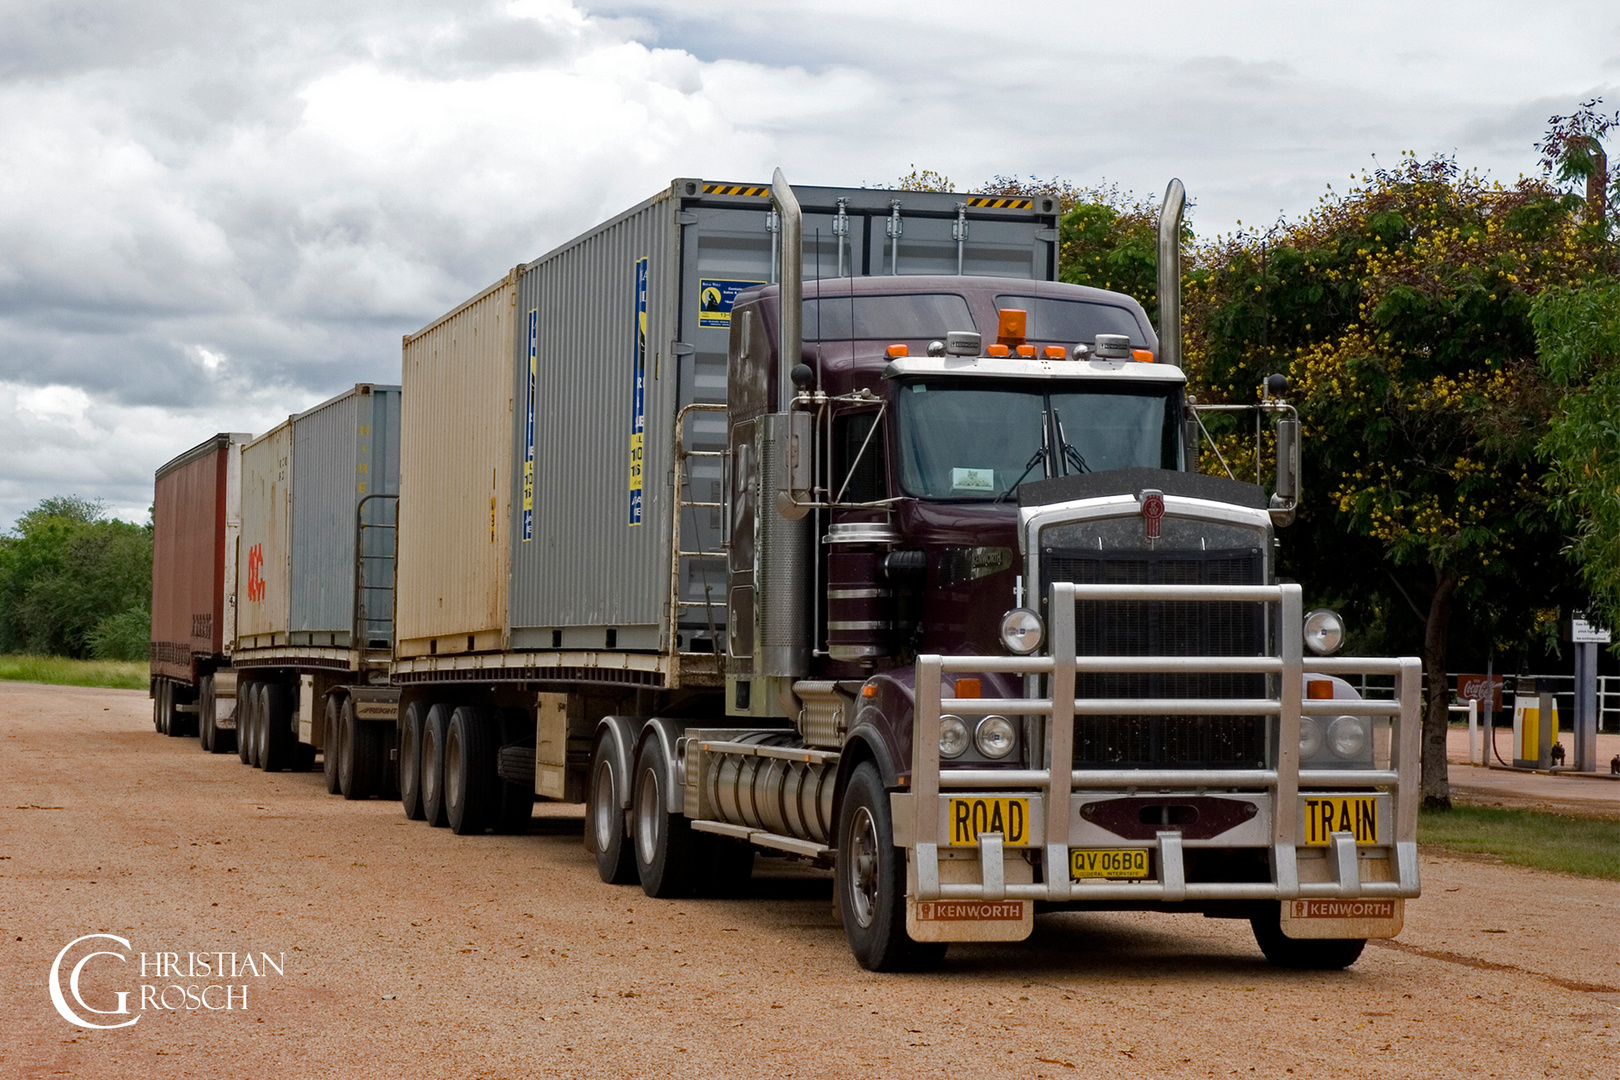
[395,270,518,657]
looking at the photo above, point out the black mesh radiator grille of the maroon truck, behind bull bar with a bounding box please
[1040,549,1265,769]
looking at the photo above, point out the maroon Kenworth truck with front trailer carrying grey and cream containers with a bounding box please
[152,172,1419,970]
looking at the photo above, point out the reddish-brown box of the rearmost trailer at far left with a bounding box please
[151,432,251,685]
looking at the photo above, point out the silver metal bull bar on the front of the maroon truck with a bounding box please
[902,581,1422,904]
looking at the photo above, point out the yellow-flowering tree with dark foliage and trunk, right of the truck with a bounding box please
[1186,157,1591,806]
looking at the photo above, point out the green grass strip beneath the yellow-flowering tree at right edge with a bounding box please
[1418,806,1620,881]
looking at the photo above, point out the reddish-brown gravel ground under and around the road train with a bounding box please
[0,683,1620,1080]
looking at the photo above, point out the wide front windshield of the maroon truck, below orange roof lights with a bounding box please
[896,381,1181,500]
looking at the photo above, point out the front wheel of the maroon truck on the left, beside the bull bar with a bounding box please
[838,761,944,972]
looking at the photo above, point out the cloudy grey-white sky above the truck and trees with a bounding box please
[0,0,1620,528]
